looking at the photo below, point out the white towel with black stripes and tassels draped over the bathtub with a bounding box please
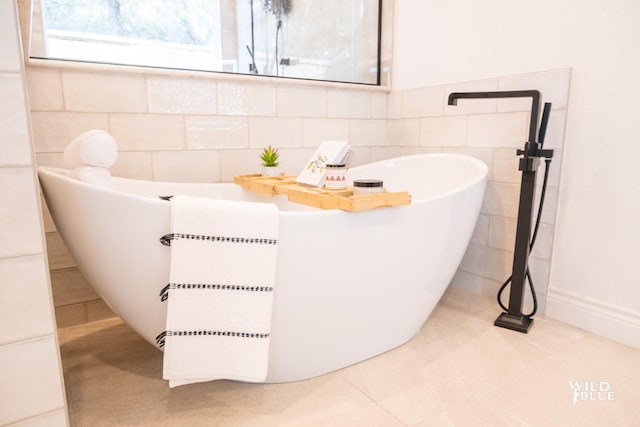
[163,196,279,387]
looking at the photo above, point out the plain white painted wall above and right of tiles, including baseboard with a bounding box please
[392,0,640,347]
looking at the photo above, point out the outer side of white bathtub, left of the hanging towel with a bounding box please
[38,167,171,344]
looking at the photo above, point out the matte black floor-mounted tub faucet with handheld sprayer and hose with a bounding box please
[448,90,553,333]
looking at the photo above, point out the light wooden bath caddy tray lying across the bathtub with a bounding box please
[233,174,411,212]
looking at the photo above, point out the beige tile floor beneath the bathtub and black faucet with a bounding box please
[59,289,640,427]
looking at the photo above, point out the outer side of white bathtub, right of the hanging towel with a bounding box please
[267,159,485,382]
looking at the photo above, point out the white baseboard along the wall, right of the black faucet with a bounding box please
[545,289,640,349]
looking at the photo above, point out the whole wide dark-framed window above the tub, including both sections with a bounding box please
[30,0,380,84]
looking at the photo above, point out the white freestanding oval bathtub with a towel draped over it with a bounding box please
[38,154,487,382]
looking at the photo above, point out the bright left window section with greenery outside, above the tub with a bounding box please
[32,0,233,71]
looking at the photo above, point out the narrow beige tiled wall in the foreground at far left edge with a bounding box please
[0,1,67,426]
